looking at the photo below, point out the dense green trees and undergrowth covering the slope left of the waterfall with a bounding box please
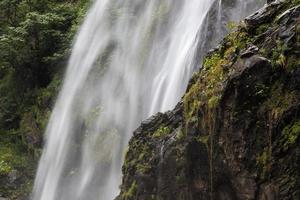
[0,0,89,199]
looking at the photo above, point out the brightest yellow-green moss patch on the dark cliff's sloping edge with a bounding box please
[183,32,239,122]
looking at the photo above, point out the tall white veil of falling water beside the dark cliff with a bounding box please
[32,0,261,200]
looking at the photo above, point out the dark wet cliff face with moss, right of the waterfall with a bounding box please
[117,0,300,200]
